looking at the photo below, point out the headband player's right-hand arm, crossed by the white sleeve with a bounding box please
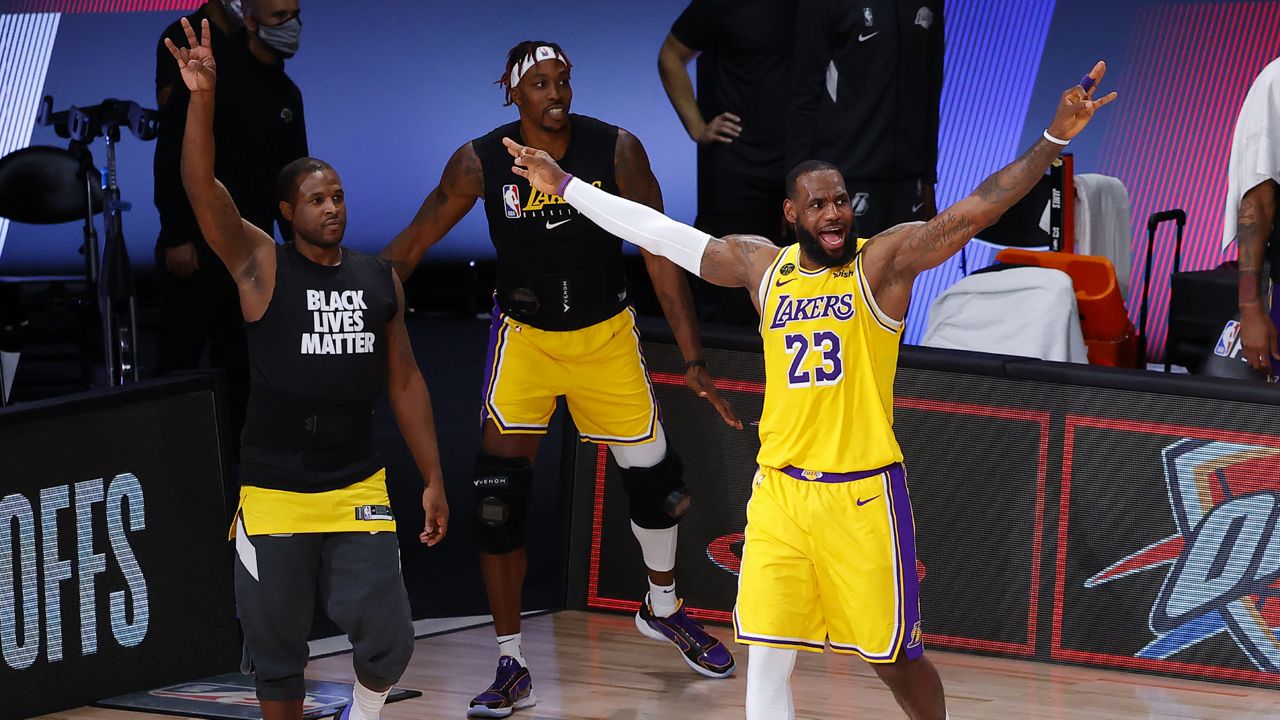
[613,128,742,429]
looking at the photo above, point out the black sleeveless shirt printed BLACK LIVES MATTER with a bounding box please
[241,243,397,492]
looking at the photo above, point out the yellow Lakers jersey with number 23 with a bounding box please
[756,240,902,473]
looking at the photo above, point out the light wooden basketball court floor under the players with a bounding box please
[45,611,1280,720]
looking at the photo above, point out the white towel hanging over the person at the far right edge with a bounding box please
[1222,59,1280,250]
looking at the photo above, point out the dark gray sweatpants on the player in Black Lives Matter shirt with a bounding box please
[236,525,413,700]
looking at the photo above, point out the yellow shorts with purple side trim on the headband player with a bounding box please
[481,302,658,445]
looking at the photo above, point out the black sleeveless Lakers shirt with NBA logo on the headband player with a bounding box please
[471,115,627,331]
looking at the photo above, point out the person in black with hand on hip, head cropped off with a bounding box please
[658,0,796,324]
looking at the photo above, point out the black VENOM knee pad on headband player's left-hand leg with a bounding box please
[472,454,534,555]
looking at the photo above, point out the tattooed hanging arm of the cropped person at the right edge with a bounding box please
[1235,181,1280,370]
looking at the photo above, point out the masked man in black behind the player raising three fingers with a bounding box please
[155,0,307,440]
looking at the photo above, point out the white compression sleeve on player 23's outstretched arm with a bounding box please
[564,178,712,277]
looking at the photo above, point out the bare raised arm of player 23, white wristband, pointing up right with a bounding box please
[863,61,1116,318]
